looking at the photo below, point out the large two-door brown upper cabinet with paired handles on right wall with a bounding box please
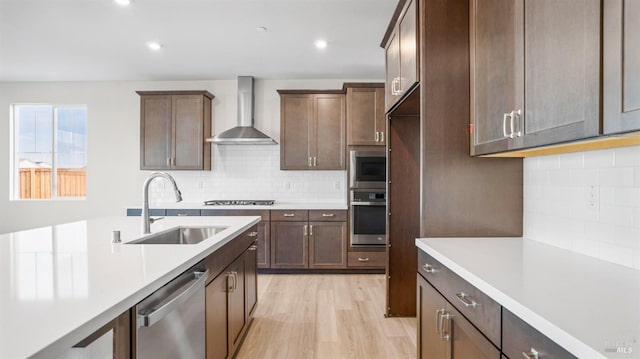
[470,0,601,155]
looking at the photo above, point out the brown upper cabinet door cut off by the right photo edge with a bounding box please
[602,0,640,134]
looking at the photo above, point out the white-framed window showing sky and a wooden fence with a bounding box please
[11,104,87,200]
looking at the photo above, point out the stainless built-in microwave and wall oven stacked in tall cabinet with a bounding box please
[349,150,387,245]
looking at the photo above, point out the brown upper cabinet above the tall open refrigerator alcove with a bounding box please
[382,0,419,111]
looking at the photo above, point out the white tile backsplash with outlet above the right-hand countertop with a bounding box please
[523,146,640,269]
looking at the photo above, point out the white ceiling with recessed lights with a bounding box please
[0,0,397,81]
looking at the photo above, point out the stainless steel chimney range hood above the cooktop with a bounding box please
[207,76,277,145]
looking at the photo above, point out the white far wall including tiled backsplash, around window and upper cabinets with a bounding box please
[0,79,360,233]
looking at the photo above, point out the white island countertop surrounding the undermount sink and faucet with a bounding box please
[0,216,260,359]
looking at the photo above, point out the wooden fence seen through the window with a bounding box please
[20,168,87,199]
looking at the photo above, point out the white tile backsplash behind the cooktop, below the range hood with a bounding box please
[150,145,347,204]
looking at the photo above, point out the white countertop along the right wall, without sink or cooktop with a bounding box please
[416,238,640,358]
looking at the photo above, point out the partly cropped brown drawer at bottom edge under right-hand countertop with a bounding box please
[502,308,575,359]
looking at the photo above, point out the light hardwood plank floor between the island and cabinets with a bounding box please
[237,274,416,359]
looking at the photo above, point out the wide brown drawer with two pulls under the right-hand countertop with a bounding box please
[418,251,501,348]
